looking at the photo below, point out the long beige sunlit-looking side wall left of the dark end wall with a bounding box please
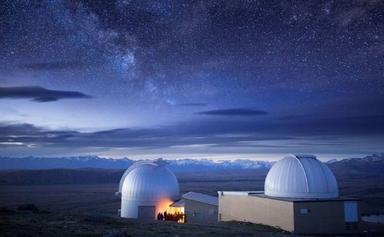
[219,194,294,231]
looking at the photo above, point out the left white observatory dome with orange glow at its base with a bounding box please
[119,160,180,220]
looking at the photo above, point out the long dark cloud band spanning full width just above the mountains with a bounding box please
[0,116,384,149]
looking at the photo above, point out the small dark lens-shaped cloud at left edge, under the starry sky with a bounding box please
[0,86,91,102]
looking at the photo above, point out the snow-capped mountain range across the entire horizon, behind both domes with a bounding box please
[0,154,384,172]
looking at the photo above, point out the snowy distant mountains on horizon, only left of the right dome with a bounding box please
[0,156,273,172]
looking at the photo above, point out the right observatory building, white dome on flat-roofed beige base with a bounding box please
[218,155,360,234]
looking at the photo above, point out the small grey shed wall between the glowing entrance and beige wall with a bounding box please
[184,199,218,223]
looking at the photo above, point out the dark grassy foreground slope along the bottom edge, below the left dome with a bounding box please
[0,210,287,237]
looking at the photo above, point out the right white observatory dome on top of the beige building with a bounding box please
[264,155,339,199]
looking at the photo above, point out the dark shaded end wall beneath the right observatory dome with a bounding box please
[294,200,360,234]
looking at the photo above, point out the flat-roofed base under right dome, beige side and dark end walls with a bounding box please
[219,194,360,234]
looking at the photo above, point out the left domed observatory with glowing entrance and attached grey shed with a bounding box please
[116,159,218,223]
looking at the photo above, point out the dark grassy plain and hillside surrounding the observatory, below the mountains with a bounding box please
[0,170,384,236]
